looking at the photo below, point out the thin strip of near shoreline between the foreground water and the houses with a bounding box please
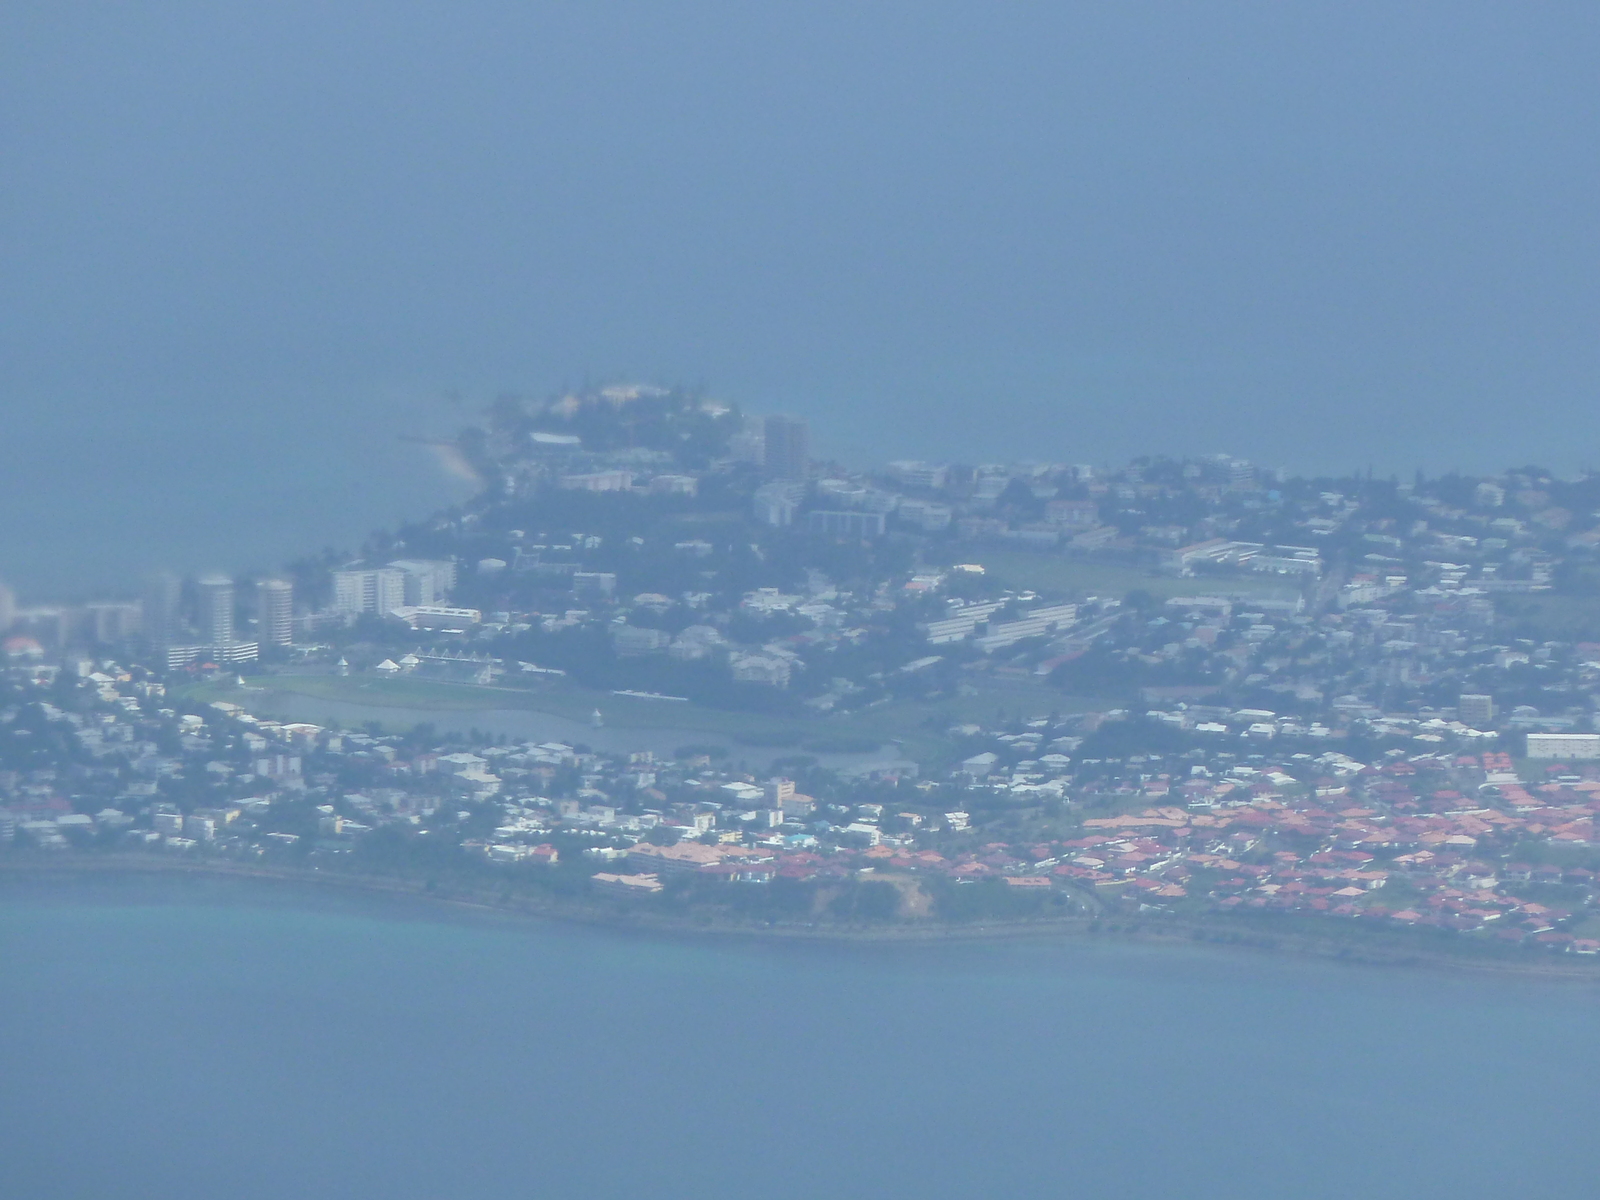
[0,854,1600,984]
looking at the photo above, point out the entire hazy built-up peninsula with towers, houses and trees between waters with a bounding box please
[9,386,1600,960]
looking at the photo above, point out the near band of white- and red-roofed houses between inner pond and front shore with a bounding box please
[9,649,1600,954]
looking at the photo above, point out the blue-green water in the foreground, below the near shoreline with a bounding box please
[0,882,1600,1200]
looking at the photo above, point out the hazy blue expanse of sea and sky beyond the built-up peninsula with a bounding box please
[0,0,1600,589]
